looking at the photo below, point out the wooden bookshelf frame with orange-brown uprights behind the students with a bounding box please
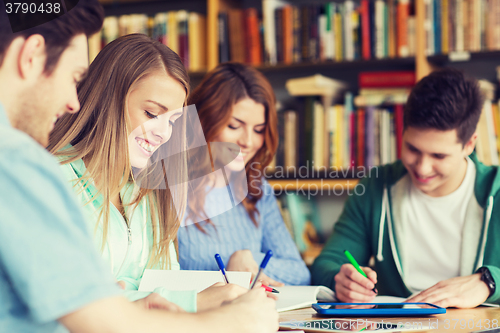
[94,0,500,190]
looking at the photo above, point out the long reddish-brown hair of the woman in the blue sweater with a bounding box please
[187,63,278,229]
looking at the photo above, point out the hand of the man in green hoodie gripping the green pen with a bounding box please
[335,264,377,303]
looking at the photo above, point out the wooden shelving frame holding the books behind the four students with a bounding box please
[94,0,500,189]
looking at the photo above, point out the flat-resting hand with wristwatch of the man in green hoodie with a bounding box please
[406,273,490,309]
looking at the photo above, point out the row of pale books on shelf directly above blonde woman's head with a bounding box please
[89,10,207,72]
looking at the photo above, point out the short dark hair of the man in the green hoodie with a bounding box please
[403,68,484,144]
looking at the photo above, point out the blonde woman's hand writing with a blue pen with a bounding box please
[197,282,248,311]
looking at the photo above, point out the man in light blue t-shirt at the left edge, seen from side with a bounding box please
[0,0,278,333]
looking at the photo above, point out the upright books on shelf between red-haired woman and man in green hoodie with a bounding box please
[276,98,403,170]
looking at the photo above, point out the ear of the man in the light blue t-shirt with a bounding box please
[18,35,47,80]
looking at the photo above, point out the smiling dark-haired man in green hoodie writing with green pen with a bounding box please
[312,69,500,308]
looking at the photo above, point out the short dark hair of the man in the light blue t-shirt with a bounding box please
[0,0,104,73]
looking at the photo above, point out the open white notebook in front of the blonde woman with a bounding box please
[139,269,252,293]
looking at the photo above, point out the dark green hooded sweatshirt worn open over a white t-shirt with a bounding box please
[311,154,500,304]
